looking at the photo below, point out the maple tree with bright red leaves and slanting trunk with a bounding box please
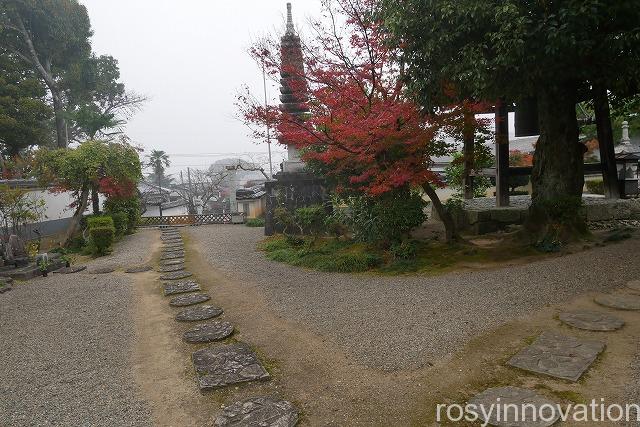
[238,0,481,240]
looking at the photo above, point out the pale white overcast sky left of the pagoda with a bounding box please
[80,0,320,173]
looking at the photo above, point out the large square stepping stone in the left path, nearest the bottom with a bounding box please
[191,344,269,390]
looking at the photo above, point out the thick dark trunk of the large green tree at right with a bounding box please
[527,82,585,242]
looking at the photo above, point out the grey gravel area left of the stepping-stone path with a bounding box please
[0,232,153,427]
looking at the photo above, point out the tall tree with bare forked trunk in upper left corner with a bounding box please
[0,0,92,148]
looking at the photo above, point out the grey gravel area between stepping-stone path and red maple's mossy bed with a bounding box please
[188,225,640,370]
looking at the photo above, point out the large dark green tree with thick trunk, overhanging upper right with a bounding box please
[382,0,640,237]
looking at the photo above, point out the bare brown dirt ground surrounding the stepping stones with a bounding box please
[130,233,640,426]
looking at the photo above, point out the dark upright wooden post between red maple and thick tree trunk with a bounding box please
[495,99,509,207]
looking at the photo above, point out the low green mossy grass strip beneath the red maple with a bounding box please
[259,236,539,275]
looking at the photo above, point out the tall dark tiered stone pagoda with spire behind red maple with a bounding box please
[279,3,309,173]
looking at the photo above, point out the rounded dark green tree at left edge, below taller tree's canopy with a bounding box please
[0,55,53,160]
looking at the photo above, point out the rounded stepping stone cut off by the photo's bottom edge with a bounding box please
[213,397,299,427]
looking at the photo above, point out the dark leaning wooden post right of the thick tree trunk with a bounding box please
[593,83,620,199]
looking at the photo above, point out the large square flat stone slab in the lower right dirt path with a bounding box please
[507,331,604,381]
